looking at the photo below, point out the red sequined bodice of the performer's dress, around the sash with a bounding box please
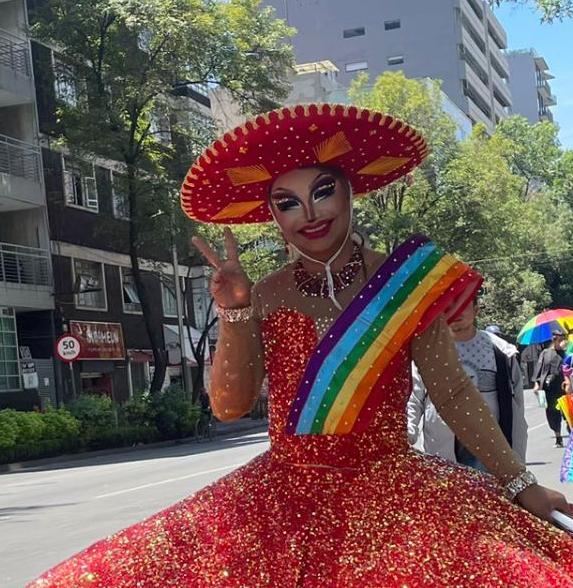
[263,307,411,467]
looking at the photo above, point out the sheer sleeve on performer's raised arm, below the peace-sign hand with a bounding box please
[209,287,264,421]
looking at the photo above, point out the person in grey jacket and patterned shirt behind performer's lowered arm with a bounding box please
[408,298,527,470]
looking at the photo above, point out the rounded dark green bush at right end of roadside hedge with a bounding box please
[152,386,201,439]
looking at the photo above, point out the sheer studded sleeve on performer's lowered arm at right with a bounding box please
[412,317,525,484]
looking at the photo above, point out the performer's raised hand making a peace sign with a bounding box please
[192,227,251,308]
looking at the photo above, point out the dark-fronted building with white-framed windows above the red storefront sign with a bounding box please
[32,42,214,401]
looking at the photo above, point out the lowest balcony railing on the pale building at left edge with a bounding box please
[0,243,51,286]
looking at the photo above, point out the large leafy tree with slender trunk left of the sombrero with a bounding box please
[32,0,292,393]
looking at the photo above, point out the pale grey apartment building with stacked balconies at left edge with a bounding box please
[0,0,57,409]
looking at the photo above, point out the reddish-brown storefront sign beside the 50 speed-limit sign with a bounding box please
[70,321,125,360]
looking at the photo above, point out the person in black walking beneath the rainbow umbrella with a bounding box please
[533,330,567,447]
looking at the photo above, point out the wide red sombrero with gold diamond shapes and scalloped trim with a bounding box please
[181,104,428,224]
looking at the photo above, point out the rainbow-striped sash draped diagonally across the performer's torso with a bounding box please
[286,235,482,435]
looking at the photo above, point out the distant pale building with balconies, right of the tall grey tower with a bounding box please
[507,49,557,124]
